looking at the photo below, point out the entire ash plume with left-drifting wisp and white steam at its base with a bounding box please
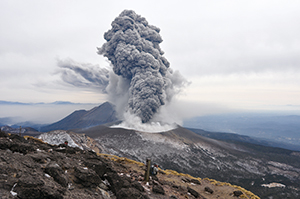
[58,10,188,128]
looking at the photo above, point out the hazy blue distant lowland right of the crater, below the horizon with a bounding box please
[184,113,300,149]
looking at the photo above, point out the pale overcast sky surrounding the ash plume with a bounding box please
[0,0,300,122]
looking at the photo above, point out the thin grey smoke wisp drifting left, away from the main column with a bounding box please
[57,59,109,93]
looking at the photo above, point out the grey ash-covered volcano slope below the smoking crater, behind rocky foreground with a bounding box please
[73,126,300,198]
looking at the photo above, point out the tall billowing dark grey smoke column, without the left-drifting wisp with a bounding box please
[98,10,186,123]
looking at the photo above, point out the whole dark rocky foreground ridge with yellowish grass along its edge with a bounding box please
[0,131,258,199]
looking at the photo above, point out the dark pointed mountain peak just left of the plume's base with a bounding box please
[40,102,117,132]
